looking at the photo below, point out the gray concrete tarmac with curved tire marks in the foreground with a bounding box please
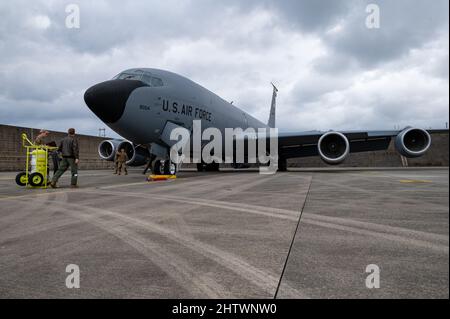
[0,168,449,298]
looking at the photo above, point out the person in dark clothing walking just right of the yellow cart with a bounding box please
[50,128,80,188]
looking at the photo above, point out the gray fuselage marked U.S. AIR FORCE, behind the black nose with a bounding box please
[100,69,267,144]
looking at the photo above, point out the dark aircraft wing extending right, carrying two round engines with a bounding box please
[278,128,448,159]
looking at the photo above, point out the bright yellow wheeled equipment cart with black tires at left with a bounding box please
[16,133,58,188]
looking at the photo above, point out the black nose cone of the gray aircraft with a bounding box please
[84,80,148,123]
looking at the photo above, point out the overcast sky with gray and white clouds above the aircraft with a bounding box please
[0,0,449,136]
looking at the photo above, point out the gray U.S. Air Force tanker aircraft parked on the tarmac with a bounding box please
[84,68,437,175]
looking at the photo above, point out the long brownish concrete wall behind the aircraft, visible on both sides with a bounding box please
[0,125,449,171]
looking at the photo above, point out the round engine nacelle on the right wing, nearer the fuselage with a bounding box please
[317,132,350,165]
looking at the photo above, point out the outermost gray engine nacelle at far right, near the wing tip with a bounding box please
[395,127,431,158]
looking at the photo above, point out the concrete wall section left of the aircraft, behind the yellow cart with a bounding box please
[0,125,112,171]
